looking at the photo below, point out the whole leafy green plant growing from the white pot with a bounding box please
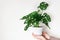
[21,2,51,31]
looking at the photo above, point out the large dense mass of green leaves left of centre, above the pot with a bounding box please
[22,11,42,30]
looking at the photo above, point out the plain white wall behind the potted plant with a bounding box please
[0,0,60,40]
